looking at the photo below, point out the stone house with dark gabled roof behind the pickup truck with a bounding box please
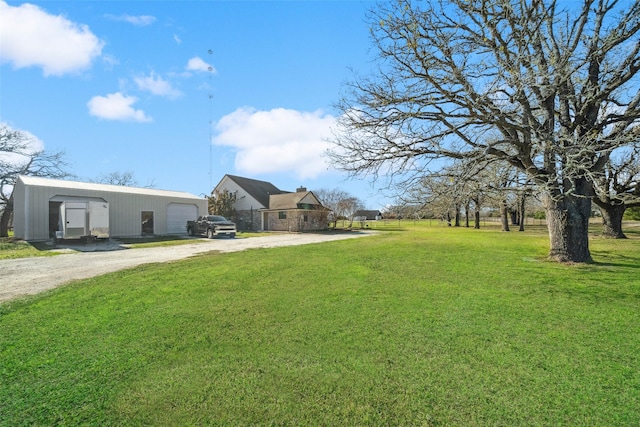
[214,175,328,232]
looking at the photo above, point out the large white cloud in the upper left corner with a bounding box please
[0,0,104,76]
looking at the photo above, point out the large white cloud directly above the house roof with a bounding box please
[212,108,335,179]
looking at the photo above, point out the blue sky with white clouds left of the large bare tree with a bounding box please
[0,0,390,209]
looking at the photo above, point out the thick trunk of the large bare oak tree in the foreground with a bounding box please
[545,195,592,263]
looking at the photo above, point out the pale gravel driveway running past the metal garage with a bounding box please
[0,231,371,303]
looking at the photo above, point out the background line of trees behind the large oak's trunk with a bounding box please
[395,157,640,238]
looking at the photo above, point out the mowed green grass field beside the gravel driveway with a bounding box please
[0,226,640,426]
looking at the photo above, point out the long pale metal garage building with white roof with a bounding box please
[13,176,207,240]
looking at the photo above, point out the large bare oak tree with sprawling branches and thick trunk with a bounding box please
[331,0,640,262]
